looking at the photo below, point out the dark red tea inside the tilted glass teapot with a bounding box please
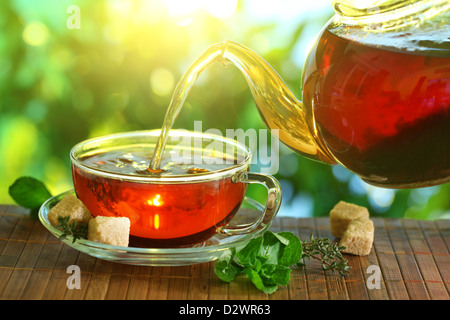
[303,30,450,187]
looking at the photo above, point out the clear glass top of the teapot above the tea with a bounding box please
[333,0,450,30]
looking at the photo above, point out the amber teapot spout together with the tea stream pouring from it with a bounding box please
[153,41,336,172]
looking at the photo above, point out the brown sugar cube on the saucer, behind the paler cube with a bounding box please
[48,194,92,227]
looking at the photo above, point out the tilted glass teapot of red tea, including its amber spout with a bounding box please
[154,0,450,188]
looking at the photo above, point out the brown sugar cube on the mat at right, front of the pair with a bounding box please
[339,218,374,256]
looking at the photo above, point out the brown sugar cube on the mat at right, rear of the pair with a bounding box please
[330,201,369,238]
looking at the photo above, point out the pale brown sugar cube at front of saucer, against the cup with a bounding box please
[88,216,130,247]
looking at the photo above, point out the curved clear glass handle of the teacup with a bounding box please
[217,171,281,235]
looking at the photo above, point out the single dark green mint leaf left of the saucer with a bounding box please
[9,177,52,218]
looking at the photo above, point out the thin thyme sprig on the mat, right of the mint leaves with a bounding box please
[298,234,351,276]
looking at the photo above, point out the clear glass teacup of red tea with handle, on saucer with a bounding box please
[70,130,281,247]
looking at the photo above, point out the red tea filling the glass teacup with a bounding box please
[72,149,246,247]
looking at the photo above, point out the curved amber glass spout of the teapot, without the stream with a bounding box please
[218,41,336,164]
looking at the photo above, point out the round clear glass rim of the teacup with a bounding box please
[70,129,252,184]
